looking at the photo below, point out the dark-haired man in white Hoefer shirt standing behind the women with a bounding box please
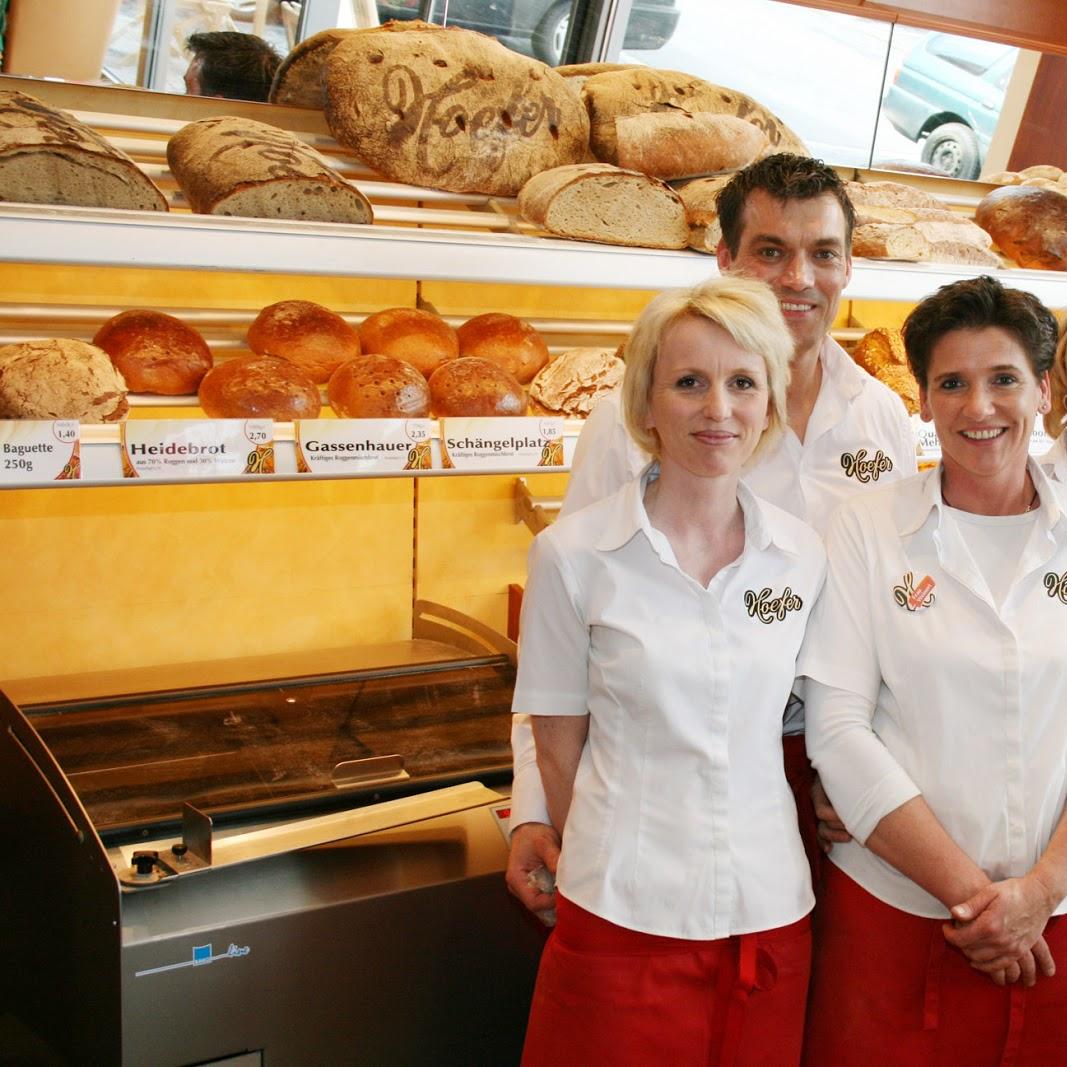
[507,154,915,913]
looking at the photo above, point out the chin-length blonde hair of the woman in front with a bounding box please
[622,274,793,466]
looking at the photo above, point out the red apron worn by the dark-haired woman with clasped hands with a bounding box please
[803,862,1067,1067]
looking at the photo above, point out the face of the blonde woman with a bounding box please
[646,316,770,477]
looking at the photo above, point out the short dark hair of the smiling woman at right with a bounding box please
[903,274,1058,387]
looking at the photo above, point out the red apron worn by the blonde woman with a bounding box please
[523,896,811,1067]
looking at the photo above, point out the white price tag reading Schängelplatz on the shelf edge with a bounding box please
[441,417,563,471]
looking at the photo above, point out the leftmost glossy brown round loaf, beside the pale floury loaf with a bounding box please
[93,309,212,396]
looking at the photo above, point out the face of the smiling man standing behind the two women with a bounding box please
[718,189,853,355]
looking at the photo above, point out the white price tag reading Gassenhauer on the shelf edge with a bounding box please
[296,418,434,474]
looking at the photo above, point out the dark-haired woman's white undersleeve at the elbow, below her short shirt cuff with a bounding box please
[805,679,920,845]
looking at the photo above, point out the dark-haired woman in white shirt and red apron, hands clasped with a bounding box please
[799,277,1067,1067]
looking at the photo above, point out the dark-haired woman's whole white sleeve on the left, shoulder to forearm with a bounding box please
[798,504,920,844]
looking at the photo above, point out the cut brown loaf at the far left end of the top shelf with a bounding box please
[0,89,168,211]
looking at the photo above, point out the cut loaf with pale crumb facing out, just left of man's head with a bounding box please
[519,163,689,249]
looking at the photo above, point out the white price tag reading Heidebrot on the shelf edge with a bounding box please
[122,418,274,479]
